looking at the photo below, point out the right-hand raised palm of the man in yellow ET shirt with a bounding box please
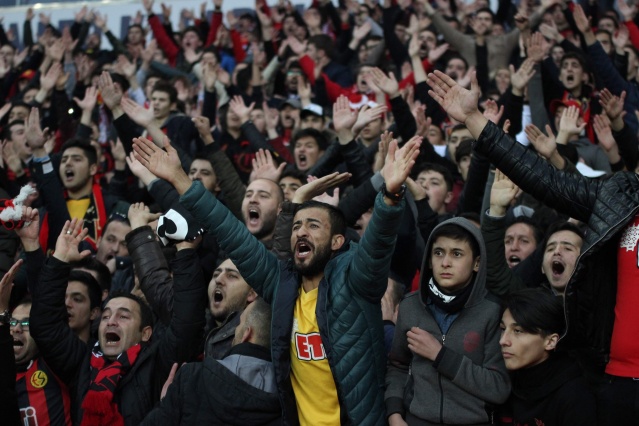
[381,136,422,194]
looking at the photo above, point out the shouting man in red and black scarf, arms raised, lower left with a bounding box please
[29,221,206,426]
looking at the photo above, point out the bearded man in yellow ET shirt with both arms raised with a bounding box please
[134,131,421,425]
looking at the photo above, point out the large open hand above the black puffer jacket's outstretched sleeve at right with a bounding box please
[428,71,479,123]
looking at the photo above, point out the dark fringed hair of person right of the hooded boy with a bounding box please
[506,288,566,337]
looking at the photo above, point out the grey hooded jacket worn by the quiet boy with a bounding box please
[385,218,510,425]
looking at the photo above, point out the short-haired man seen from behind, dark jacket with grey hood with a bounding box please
[142,299,282,426]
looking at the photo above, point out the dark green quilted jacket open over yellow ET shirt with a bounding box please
[180,182,405,425]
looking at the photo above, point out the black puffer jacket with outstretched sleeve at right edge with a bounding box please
[475,122,639,372]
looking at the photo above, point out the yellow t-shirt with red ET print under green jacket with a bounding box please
[291,287,340,426]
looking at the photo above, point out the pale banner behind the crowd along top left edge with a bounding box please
[0,0,310,48]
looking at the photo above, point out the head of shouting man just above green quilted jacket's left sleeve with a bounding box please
[242,179,284,248]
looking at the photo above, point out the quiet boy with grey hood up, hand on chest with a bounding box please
[385,218,510,425]
